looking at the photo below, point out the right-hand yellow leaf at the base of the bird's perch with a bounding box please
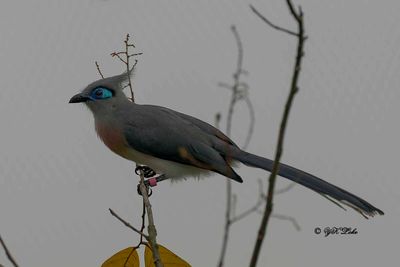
[144,245,191,267]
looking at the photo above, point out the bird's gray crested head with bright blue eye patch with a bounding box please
[69,69,129,115]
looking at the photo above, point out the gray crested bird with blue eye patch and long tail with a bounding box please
[69,70,384,217]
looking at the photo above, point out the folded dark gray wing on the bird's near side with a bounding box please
[124,105,242,182]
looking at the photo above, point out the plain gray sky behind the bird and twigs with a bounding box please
[0,0,400,267]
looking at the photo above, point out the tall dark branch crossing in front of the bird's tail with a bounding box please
[250,0,305,267]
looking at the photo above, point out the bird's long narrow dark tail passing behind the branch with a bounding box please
[233,151,384,218]
